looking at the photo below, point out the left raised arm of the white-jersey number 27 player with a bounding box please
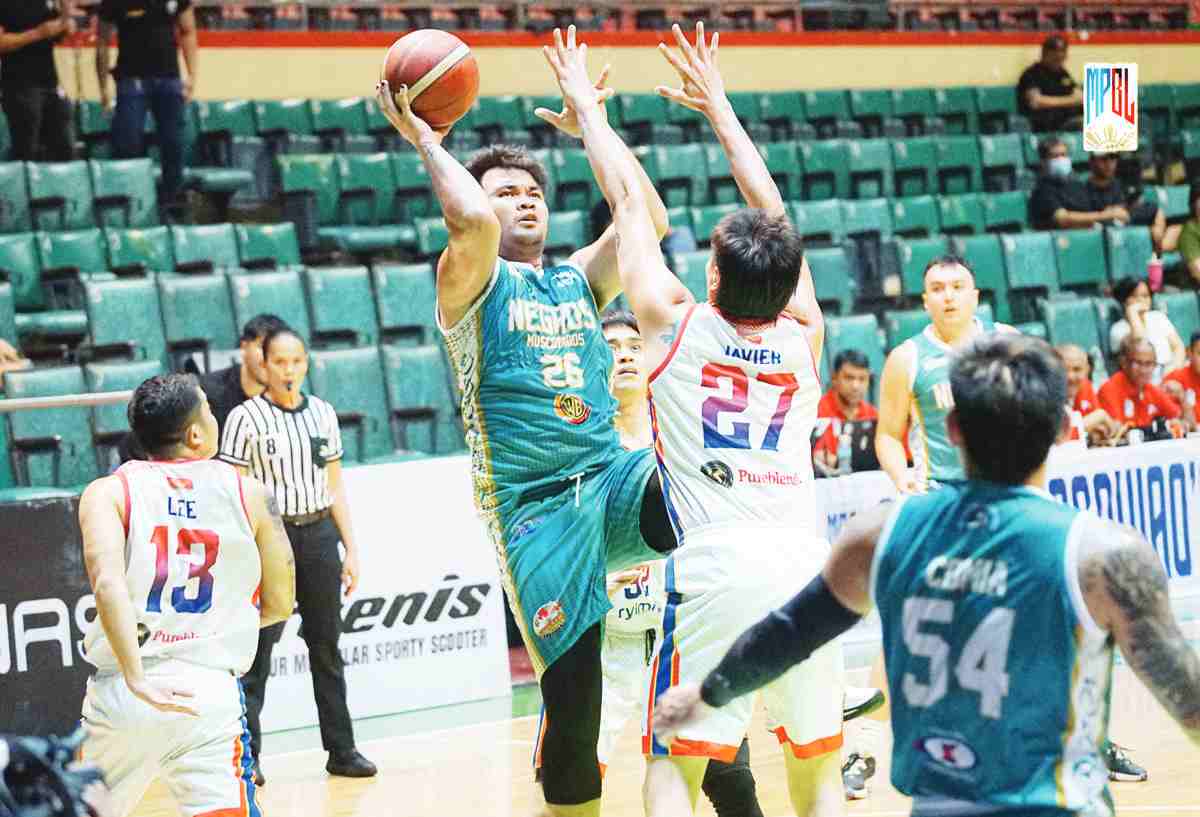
[544,25,692,366]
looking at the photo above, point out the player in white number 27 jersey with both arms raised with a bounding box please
[544,25,845,817]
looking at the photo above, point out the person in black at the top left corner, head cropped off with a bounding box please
[0,0,74,162]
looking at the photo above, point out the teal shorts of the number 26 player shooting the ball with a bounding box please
[503,449,662,678]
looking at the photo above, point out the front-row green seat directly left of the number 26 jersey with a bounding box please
[380,344,464,453]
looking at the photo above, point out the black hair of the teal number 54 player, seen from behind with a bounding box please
[950,332,1067,485]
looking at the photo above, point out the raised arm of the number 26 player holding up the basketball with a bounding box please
[376,79,500,328]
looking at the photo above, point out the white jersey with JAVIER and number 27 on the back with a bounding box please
[649,304,824,537]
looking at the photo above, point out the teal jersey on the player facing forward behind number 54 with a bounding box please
[905,318,995,482]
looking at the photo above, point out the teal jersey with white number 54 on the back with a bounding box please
[870,481,1112,817]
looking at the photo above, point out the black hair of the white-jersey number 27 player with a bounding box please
[712,208,804,322]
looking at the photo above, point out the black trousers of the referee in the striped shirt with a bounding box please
[241,518,354,759]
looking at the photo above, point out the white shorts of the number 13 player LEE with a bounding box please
[82,661,263,817]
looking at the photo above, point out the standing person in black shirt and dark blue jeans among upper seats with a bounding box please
[96,0,198,213]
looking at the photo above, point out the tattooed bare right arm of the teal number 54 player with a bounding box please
[1079,522,1200,747]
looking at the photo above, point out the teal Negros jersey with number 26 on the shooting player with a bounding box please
[444,259,623,518]
